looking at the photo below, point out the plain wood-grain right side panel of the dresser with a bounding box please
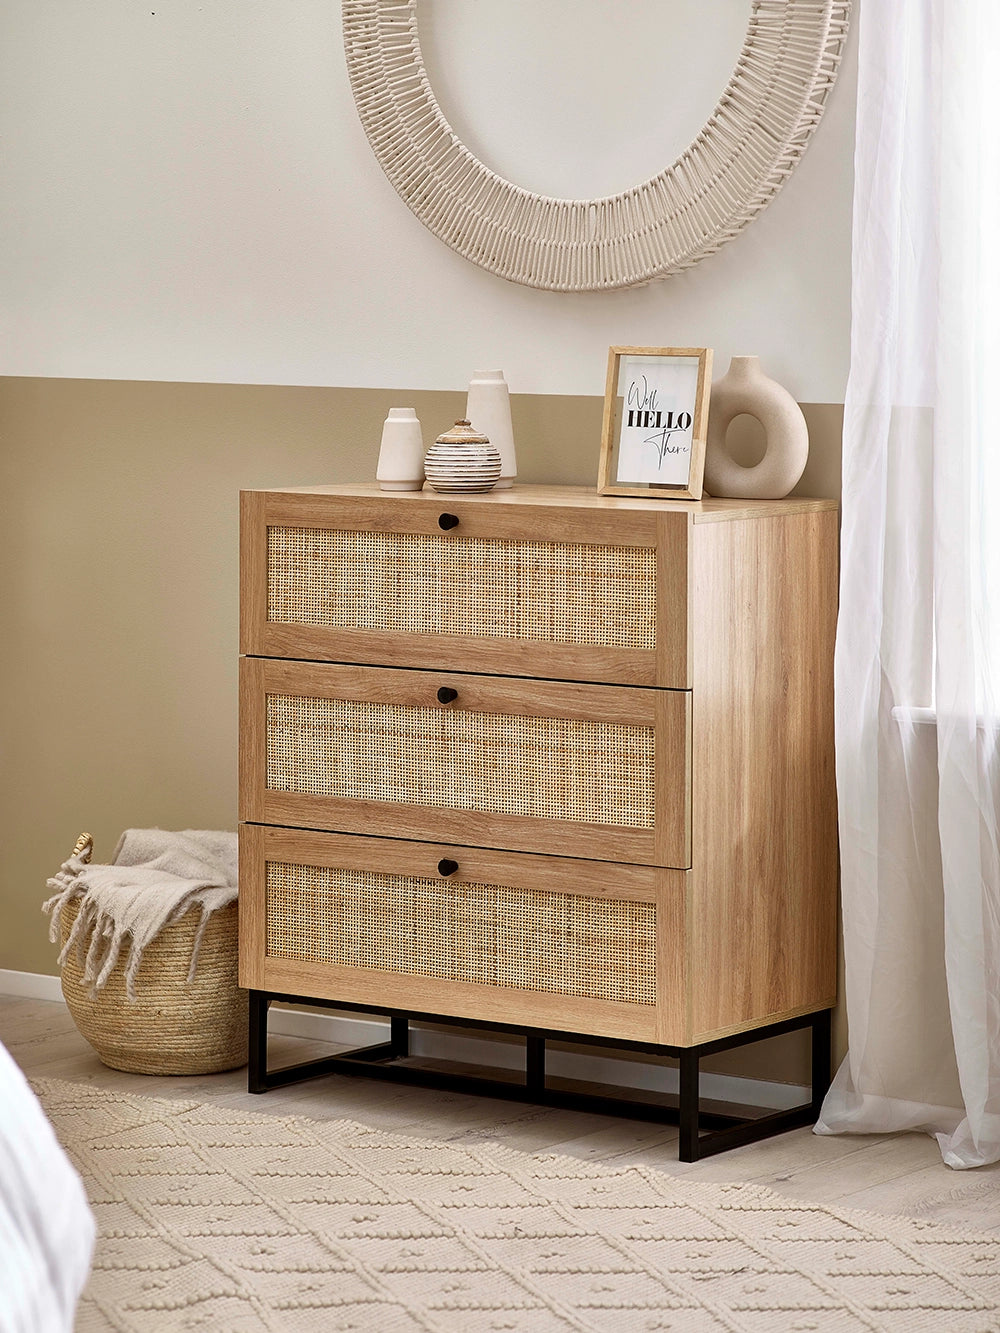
[691,511,837,1036]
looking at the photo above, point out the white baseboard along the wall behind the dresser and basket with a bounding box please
[0,968,809,1110]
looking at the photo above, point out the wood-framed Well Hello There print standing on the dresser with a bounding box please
[597,347,712,500]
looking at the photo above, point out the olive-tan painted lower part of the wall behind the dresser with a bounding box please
[0,379,843,1071]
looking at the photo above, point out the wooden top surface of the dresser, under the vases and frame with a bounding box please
[249,483,839,523]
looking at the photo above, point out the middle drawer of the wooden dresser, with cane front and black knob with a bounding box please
[240,657,691,869]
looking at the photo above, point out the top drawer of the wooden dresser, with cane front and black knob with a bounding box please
[240,492,688,688]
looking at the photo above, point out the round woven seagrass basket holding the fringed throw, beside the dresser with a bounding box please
[60,837,247,1074]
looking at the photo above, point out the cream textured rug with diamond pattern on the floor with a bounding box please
[27,1078,1000,1333]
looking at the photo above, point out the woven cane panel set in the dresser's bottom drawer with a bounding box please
[267,861,656,1005]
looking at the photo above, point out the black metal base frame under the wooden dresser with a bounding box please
[248,990,831,1162]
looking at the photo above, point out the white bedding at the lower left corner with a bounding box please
[0,1045,95,1333]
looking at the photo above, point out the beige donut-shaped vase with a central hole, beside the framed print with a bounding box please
[705,356,809,500]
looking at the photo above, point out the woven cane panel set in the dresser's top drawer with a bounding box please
[268,528,656,648]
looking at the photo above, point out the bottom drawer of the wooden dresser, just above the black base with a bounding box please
[240,824,687,1042]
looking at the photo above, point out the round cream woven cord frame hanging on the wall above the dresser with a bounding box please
[343,0,851,292]
